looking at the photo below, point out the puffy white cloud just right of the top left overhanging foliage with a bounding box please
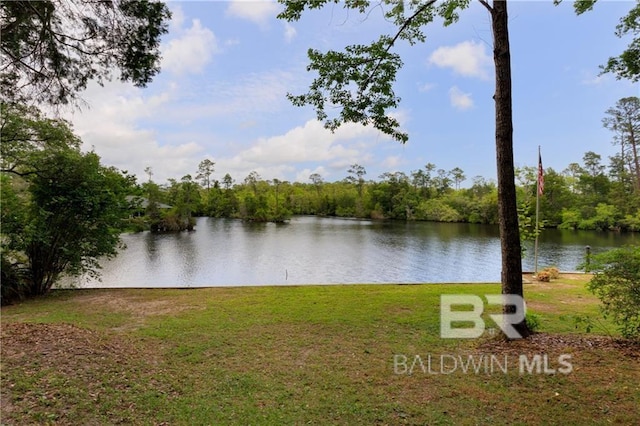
[162,19,219,75]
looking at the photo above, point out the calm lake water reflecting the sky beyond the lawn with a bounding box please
[70,216,640,287]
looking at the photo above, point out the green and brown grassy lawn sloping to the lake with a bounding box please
[0,277,640,425]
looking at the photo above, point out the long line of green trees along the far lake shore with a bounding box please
[137,145,640,234]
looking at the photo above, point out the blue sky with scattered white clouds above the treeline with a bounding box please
[62,0,640,186]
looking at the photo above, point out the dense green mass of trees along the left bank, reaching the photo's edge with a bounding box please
[0,104,134,303]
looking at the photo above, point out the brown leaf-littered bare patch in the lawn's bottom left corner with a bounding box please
[0,323,169,425]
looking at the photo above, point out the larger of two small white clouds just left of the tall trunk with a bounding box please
[429,41,492,79]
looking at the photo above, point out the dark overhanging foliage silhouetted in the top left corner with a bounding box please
[0,0,171,106]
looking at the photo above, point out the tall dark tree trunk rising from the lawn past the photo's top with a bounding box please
[490,0,529,337]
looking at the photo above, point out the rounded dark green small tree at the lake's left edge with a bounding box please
[22,151,126,295]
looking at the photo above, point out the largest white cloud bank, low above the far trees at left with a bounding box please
[67,66,312,183]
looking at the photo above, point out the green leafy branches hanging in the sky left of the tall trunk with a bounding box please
[278,0,470,143]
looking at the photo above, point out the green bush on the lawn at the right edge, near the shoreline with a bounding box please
[587,247,640,339]
